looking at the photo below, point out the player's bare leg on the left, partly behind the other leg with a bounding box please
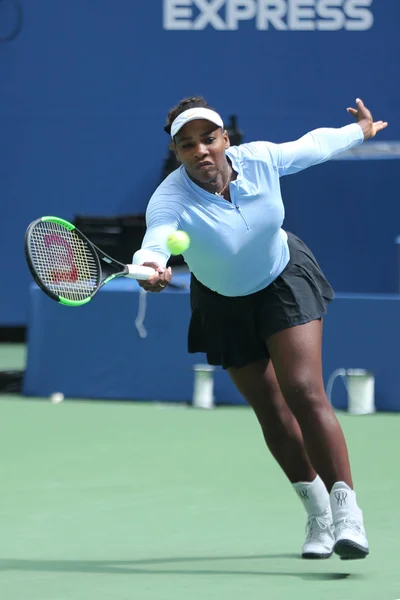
[228,360,316,483]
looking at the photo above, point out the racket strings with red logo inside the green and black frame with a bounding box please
[30,221,100,300]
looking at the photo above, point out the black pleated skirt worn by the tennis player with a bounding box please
[188,233,334,369]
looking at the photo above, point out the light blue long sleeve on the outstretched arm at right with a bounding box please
[269,123,364,176]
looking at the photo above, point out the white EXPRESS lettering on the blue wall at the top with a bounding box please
[162,0,376,31]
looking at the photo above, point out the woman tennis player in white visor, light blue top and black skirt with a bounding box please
[133,97,387,559]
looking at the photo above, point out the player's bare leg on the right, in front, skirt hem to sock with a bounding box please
[266,321,353,491]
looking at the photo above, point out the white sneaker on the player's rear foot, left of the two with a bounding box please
[302,508,335,559]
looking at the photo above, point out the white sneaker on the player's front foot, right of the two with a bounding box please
[334,510,369,560]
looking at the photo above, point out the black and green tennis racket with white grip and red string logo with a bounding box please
[25,217,155,306]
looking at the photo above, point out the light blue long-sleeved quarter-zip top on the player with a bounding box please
[133,123,364,296]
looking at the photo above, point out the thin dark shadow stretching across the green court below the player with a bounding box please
[0,554,360,581]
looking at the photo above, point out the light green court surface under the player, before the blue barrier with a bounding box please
[0,396,400,600]
